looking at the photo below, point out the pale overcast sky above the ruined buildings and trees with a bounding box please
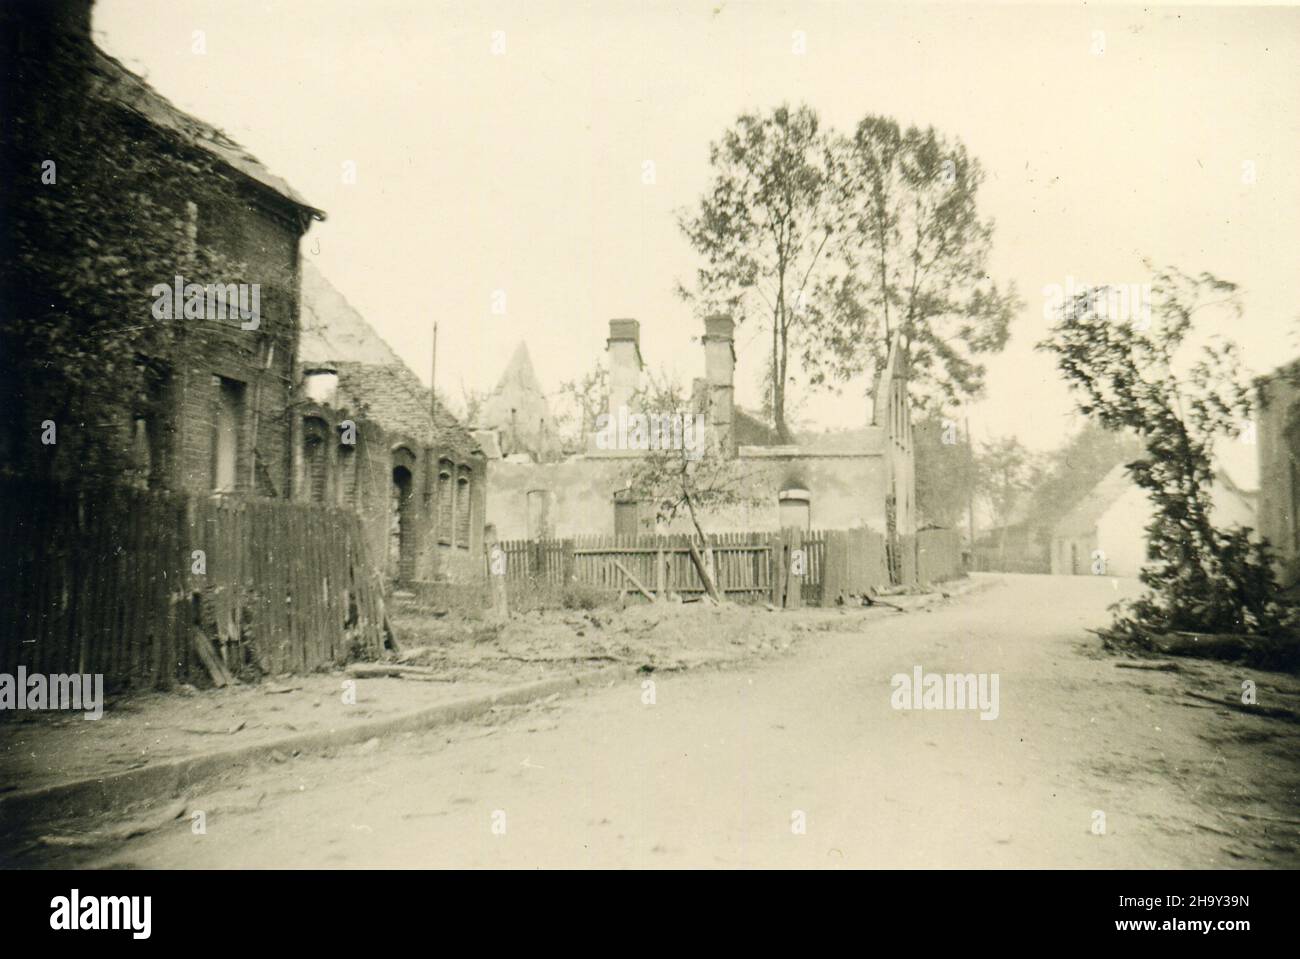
[95,0,1300,481]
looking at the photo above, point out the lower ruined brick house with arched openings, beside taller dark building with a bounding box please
[295,262,486,583]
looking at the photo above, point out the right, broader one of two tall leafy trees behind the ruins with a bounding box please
[803,116,1019,411]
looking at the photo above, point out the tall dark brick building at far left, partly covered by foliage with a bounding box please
[4,0,324,496]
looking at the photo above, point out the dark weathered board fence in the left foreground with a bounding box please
[0,482,384,687]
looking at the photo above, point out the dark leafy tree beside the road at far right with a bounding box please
[1039,269,1296,647]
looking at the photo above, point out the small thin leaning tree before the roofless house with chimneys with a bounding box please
[629,376,758,600]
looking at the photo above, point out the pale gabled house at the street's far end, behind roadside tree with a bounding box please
[1052,465,1255,576]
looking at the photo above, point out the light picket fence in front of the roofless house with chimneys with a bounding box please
[498,529,962,607]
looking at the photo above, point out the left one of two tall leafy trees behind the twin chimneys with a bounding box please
[677,105,845,442]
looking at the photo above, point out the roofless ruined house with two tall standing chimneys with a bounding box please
[488,316,917,553]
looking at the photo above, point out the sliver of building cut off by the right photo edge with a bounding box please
[1256,360,1300,586]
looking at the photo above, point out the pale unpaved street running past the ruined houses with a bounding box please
[63,577,1300,867]
